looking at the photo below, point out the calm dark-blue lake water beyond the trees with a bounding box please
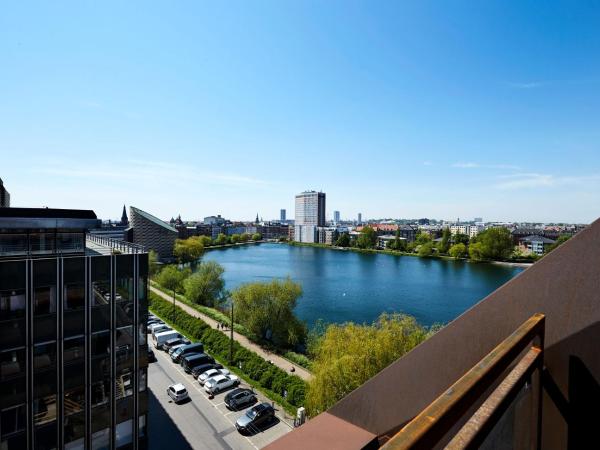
[204,244,523,326]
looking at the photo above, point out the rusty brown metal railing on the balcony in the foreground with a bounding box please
[383,314,545,450]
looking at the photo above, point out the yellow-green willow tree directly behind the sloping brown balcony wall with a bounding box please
[306,314,431,416]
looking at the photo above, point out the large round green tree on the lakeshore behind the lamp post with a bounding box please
[231,278,306,347]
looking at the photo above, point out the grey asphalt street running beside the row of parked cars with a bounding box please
[148,342,291,450]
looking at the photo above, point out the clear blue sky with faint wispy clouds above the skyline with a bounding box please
[0,0,600,222]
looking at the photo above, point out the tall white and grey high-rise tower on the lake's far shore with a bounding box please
[294,191,325,242]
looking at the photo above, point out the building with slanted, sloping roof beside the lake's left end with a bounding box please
[128,206,178,261]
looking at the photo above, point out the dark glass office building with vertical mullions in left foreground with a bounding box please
[0,208,148,450]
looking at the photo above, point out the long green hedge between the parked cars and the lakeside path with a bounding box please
[149,292,306,408]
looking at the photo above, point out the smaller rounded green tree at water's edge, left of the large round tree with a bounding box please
[183,261,225,307]
